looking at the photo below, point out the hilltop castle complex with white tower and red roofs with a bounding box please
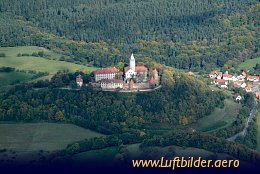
[94,54,159,90]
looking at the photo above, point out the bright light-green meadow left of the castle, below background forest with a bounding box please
[0,46,95,74]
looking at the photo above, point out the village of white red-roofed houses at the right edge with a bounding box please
[208,71,260,100]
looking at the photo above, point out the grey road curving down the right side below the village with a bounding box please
[227,98,258,141]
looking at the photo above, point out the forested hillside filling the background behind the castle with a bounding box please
[0,0,259,69]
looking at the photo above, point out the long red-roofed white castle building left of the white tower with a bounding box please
[94,67,120,82]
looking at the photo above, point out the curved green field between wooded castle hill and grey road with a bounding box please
[190,99,241,132]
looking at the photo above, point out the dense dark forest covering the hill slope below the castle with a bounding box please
[0,70,224,134]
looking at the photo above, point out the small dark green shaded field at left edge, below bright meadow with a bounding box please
[0,72,33,87]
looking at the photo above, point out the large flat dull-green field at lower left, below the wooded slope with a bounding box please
[0,123,102,151]
